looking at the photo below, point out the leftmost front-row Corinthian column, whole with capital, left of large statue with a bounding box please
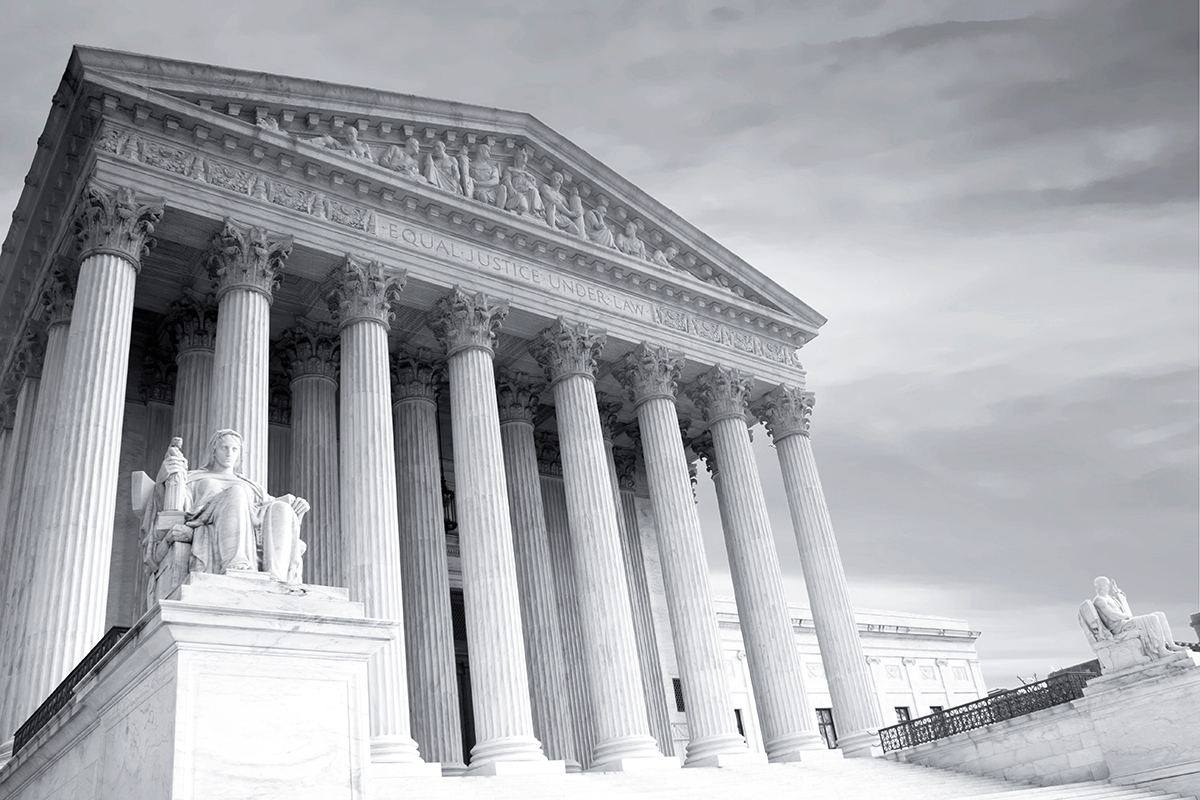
[22,184,162,709]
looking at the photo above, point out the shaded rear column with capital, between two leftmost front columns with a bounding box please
[164,295,218,470]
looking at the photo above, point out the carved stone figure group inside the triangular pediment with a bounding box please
[274,116,679,269]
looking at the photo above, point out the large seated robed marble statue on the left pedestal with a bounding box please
[146,429,308,583]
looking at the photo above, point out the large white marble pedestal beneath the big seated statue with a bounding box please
[0,573,424,800]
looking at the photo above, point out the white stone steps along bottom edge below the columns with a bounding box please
[371,758,1196,800]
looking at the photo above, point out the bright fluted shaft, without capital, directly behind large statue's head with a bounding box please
[211,287,271,486]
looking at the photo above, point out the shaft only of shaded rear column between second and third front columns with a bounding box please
[292,373,346,587]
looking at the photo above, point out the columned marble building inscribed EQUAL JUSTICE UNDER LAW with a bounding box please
[0,48,984,796]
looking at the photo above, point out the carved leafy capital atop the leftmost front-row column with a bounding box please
[74,182,164,269]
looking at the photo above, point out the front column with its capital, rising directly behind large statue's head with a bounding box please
[208,219,292,486]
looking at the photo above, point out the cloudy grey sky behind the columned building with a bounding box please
[0,0,1200,686]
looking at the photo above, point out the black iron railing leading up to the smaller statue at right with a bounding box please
[880,673,1094,752]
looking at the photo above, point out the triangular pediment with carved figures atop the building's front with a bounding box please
[68,47,826,333]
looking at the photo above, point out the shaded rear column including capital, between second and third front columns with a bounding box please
[277,320,346,587]
